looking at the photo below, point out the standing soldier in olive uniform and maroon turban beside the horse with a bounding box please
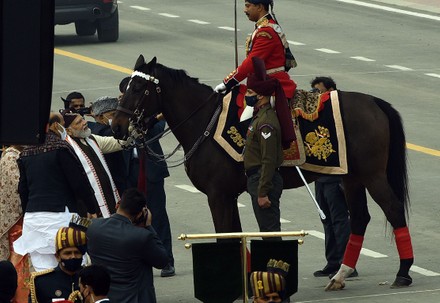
[244,57,294,240]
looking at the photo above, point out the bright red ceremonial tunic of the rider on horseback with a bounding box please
[223,14,296,99]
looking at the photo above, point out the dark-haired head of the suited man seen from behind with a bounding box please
[118,188,147,222]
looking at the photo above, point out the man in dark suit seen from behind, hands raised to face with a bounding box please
[87,188,168,303]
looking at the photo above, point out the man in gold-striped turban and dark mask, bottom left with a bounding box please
[29,218,87,303]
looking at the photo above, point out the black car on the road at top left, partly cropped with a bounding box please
[55,0,119,42]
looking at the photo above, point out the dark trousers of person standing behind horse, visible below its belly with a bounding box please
[315,181,350,268]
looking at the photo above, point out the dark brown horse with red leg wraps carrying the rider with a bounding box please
[112,55,414,290]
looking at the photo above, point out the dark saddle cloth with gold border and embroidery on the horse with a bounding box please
[214,85,348,174]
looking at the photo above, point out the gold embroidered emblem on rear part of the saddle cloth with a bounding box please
[304,126,336,162]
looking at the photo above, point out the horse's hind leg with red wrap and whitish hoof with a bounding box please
[325,180,371,291]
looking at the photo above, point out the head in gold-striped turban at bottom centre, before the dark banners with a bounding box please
[250,259,290,303]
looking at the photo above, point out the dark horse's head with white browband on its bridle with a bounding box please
[112,55,161,139]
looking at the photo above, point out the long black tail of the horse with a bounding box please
[374,98,410,215]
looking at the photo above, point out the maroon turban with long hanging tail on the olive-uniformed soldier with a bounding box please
[247,57,296,149]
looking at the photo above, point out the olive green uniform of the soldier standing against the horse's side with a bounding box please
[244,104,283,239]
